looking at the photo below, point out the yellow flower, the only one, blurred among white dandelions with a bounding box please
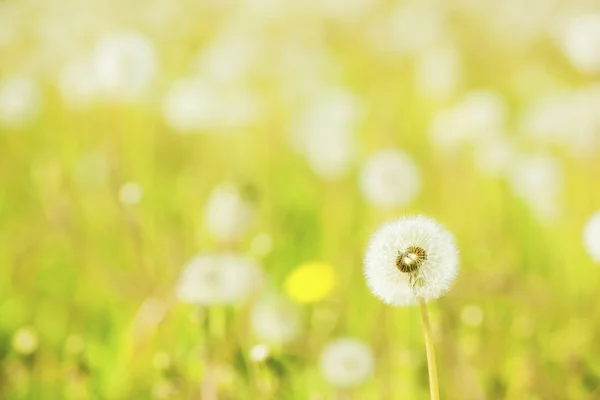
[284,261,335,303]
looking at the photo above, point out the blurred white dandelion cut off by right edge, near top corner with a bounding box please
[555,12,600,74]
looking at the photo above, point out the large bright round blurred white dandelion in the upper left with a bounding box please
[92,31,158,101]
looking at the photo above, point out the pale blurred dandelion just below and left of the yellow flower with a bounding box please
[250,296,300,344]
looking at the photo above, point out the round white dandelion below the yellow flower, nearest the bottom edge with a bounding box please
[321,338,375,388]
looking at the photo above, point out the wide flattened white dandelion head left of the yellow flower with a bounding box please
[177,253,262,306]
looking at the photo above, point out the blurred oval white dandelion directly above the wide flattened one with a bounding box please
[204,182,254,241]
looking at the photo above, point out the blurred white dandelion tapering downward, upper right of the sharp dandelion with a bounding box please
[508,155,564,221]
